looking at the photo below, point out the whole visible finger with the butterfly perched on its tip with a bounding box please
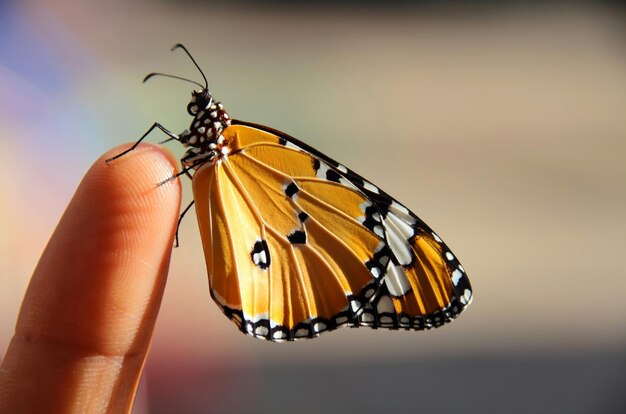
[0,144,181,413]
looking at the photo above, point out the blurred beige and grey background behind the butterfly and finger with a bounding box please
[0,0,626,413]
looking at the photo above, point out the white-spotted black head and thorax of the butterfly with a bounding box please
[179,89,231,168]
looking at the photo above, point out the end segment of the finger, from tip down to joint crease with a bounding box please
[17,144,181,355]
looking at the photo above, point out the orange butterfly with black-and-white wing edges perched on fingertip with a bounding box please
[107,44,472,342]
